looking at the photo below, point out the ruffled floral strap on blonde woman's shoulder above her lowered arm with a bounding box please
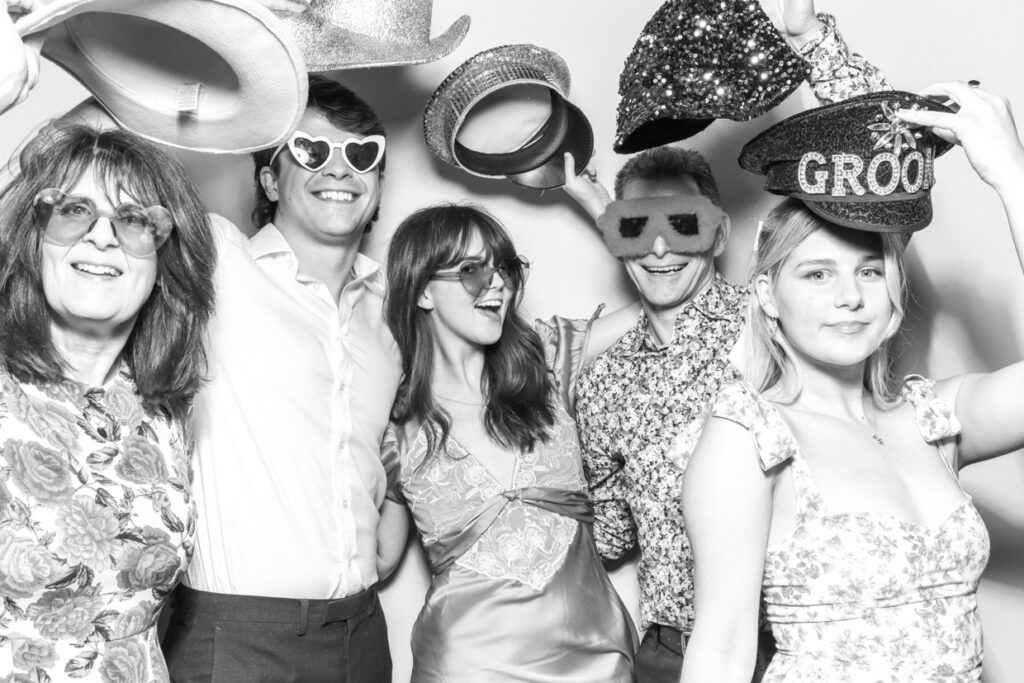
[712,381,799,471]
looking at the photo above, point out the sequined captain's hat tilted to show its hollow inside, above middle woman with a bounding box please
[423,45,594,189]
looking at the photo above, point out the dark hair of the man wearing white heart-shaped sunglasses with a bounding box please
[253,75,387,232]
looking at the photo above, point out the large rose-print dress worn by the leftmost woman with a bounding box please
[0,370,195,683]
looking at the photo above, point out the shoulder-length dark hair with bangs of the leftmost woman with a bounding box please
[0,122,216,419]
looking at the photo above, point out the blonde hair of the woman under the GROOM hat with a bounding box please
[744,199,906,408]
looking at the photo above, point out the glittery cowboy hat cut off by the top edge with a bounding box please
[278,0,469,72]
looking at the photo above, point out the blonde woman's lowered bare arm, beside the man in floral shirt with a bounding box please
[682,418,772,683]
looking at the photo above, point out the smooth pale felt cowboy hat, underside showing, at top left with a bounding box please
[14,0,307,153]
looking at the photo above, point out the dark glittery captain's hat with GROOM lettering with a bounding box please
[739,90,952,232]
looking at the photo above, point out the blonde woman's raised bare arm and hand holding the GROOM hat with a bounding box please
[899,82,1024,467]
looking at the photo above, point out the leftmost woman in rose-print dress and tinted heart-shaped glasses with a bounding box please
[0,114,214,681]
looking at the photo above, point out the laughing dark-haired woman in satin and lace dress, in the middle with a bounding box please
[385,206,636,683]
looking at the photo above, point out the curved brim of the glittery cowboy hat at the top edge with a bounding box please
[278,12,470,72]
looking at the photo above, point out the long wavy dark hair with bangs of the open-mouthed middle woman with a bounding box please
[384,204,555,455]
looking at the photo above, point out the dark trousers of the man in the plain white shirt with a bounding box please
[162,586,391,683]
